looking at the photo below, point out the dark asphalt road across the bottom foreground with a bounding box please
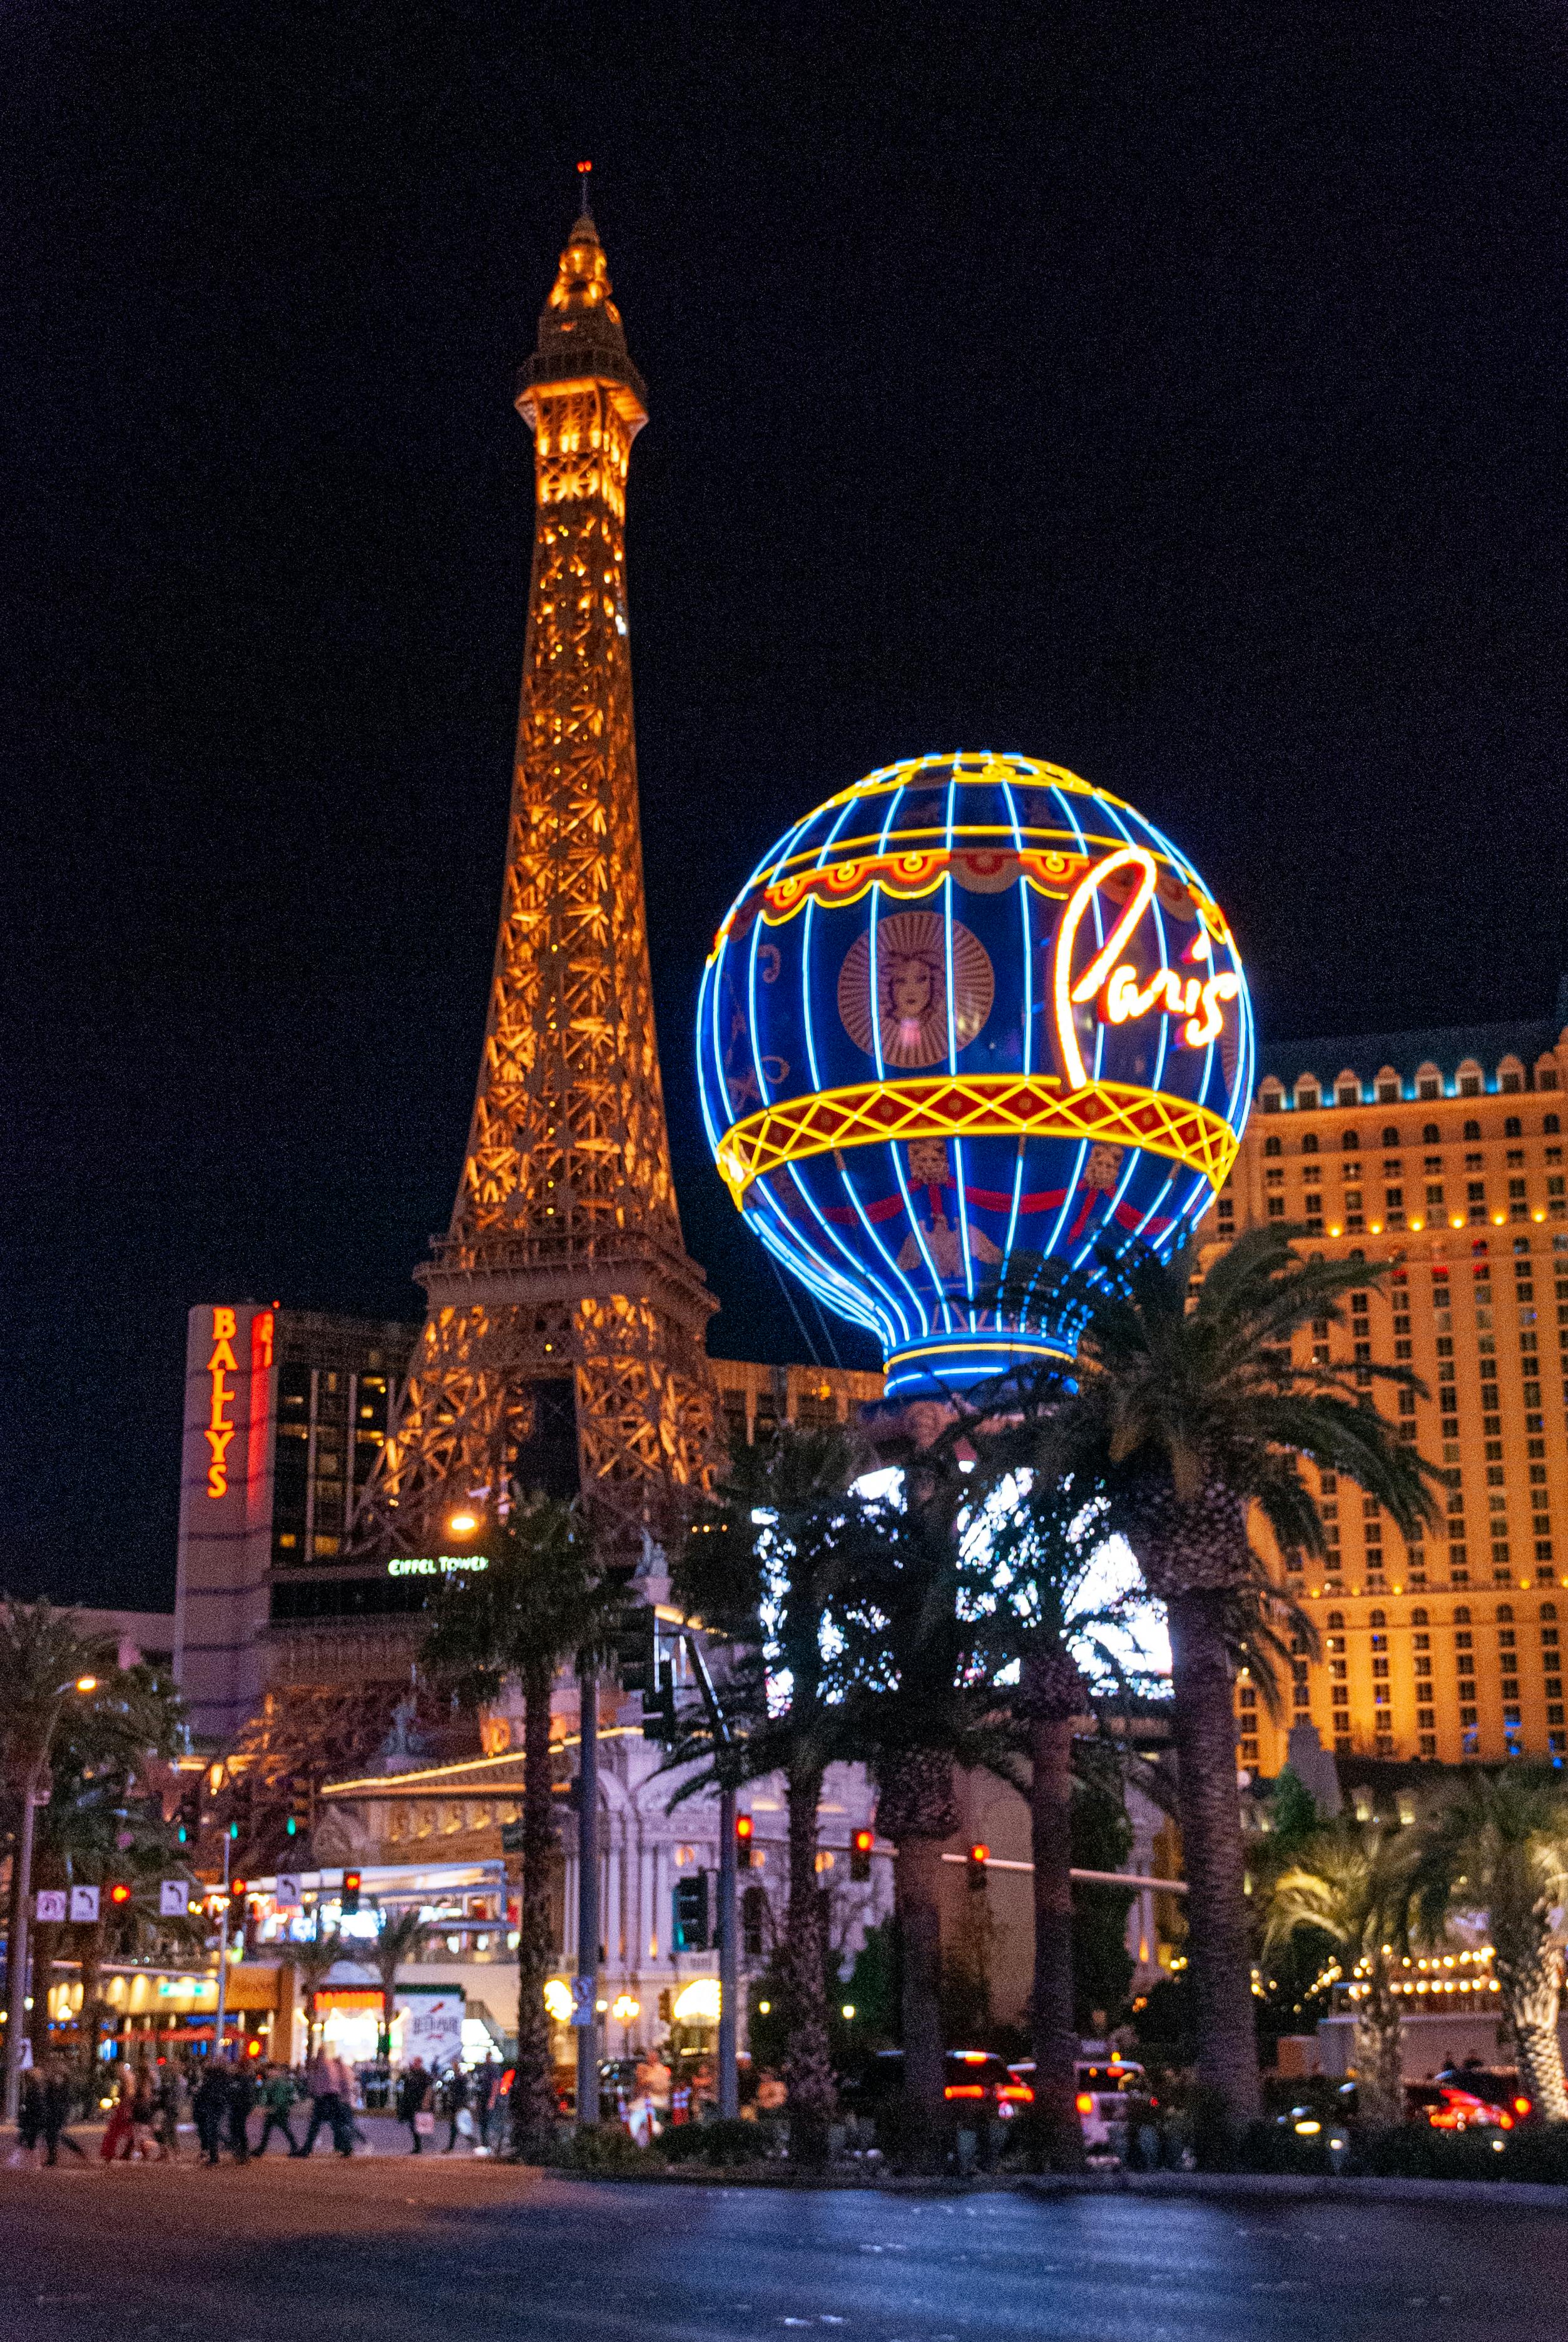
[0,2157,1564,2342]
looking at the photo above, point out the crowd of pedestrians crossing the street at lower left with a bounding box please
[12,2049,503,2164]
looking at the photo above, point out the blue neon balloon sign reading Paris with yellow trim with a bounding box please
[698,754,1252,1398]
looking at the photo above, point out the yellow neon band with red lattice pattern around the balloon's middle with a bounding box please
[718,1072,1240,1211]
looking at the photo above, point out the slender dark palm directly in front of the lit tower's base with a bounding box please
[421,1494,625,2162]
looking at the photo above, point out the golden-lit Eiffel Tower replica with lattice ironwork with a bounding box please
[363,196,716,1550]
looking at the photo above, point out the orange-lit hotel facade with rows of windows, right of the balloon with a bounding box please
[1210,984,1568,1773]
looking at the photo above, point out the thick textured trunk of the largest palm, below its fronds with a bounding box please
[1166,1590,1261,2122]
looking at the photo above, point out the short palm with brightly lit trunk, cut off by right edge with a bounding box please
[1407,1763,1568,2122]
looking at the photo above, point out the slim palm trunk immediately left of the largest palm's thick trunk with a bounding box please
[1030,1717,1084,2171]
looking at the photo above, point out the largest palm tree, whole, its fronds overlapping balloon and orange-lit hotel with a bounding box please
[1049,1223,1435,2119]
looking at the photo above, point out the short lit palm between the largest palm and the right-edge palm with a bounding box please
[1264,1822,1411,2124]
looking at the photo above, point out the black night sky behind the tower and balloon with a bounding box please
[0,0,1568,1604]
